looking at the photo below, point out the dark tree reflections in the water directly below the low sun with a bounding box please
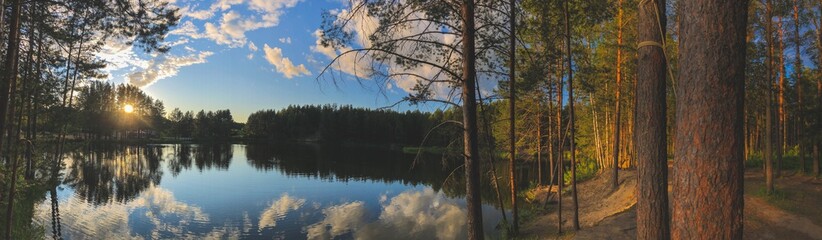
[63,144,233,205]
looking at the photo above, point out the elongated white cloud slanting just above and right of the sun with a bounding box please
[126,51,214,87]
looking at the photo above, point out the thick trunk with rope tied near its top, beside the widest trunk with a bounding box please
[634,0,671,239]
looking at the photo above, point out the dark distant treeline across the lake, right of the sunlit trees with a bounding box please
[243,105,442,145]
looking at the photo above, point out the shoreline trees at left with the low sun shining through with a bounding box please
[72,81,242,140]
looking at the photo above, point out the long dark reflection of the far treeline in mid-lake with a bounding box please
[246,144,458,189]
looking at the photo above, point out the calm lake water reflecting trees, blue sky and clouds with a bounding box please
[34,145,508,239]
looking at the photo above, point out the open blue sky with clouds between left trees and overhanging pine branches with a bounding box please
[99,0,458,122]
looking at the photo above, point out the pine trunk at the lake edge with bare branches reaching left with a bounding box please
[460,0,484,239]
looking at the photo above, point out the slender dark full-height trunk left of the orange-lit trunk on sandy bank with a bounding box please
[565,0,579,230]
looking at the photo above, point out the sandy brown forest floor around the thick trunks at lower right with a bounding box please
[520,169,822,239]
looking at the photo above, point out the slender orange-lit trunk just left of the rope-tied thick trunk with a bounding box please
[611,0,623,190]
